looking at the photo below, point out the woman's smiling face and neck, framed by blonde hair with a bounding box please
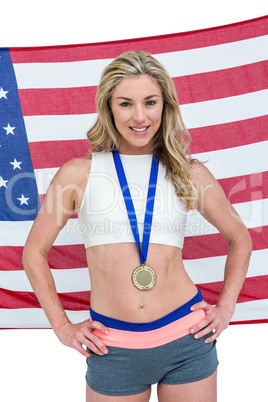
[110,75,164,155]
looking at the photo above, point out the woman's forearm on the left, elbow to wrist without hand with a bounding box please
[23,249,70,333]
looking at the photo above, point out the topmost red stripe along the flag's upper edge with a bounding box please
[10,16,268,63]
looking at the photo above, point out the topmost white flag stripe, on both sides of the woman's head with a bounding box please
[14,36,268,89]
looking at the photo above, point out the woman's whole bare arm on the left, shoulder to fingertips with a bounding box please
[23,159,109,357]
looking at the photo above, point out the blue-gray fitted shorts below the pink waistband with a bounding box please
[86,334,218,396]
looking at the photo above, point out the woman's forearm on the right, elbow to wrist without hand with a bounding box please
[217,231,252,316]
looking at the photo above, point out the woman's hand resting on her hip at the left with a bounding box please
[54,320,109,357]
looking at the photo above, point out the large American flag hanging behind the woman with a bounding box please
[0,16,268,328]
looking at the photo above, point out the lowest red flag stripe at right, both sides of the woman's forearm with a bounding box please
[196,275,268,304]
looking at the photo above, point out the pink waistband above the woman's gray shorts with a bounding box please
[90,309,206,349]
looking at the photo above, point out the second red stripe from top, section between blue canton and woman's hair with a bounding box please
[19,87,97,116]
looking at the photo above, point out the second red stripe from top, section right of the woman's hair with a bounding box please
[173,61,268,105]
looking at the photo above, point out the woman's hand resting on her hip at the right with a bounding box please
[190,301,232,343]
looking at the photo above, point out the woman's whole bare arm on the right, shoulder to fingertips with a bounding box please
[187,162,252,342]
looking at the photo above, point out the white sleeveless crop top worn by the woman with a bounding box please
[78,152,187,248]
